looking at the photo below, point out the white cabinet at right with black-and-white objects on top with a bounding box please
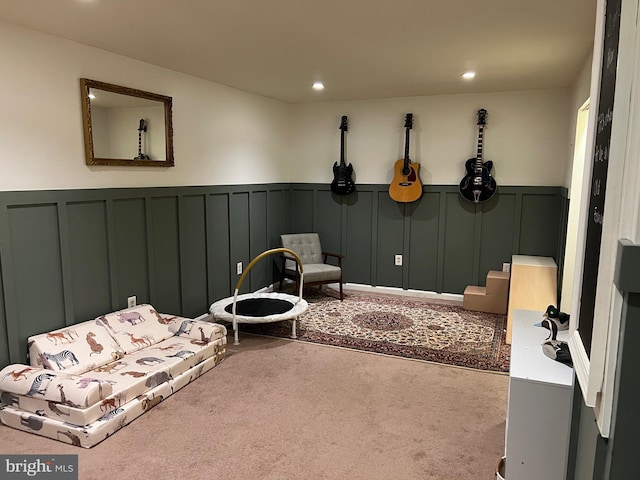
[505,310,574,480]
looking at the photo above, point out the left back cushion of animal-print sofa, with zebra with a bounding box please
[28,320,123,374]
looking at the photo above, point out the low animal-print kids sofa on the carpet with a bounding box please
[0,305,227,448]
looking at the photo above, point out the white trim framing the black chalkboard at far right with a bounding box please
[569,0,640,437]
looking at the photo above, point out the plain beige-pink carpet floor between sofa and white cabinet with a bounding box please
[0,334,508,480]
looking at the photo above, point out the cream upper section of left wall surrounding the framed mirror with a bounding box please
[0,22,290,190]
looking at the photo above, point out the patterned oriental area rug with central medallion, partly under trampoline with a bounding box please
[240,288,510,372]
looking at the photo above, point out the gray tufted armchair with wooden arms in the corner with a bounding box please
[280,233,343,300]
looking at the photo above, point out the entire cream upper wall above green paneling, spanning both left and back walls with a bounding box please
[0,22,574,190]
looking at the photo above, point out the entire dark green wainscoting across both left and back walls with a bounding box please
[0,184,568,366]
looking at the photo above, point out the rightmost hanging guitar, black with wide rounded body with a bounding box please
[460,108,498,203]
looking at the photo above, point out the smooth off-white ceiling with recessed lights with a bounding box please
[0,0,596,103]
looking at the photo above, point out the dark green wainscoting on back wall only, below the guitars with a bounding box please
[291,184,568,293]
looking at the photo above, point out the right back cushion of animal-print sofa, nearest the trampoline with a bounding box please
[96,304,176,353]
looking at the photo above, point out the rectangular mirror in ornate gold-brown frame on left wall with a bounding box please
[80,78,174,167]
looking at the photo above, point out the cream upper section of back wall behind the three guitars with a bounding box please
[291,89,572,185]
